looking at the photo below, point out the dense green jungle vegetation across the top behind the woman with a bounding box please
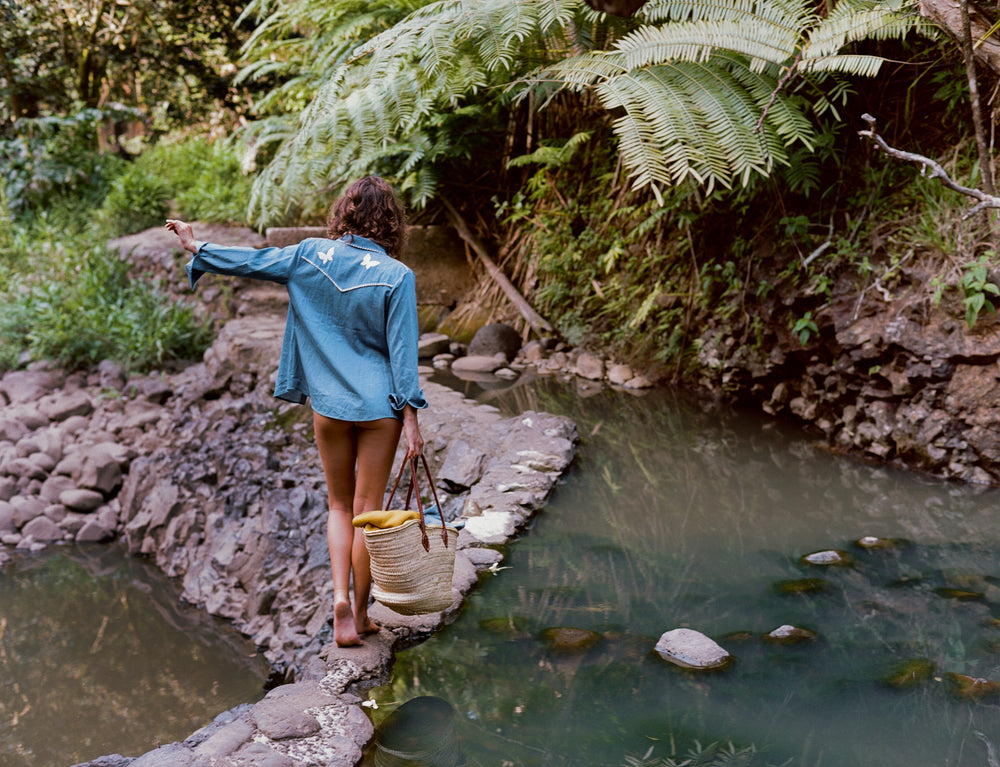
[0,0,995,379]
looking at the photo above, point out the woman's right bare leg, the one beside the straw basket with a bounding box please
[351,418,403,634]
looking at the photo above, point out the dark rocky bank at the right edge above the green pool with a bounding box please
[694,265,1000,486]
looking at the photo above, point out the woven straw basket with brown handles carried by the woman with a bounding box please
[364,456,458,615]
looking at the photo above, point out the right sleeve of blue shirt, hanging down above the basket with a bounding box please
[386,269,427,411]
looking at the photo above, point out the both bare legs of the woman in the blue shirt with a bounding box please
[313,413,401,647]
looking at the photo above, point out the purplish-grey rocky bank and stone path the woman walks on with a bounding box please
[0,225,592,767]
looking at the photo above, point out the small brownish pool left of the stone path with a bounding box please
[0,546,267,767]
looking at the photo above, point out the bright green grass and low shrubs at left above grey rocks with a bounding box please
[0,131,251,372]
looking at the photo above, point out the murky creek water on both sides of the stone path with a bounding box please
[0,380,1000,767]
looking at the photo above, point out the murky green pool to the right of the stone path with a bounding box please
[377,381,1000,767]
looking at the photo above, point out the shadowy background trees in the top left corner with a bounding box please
[0,0,245,131]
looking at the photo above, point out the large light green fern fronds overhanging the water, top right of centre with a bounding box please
[528,0,914,194]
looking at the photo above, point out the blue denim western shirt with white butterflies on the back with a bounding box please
[186,235,427,421]
